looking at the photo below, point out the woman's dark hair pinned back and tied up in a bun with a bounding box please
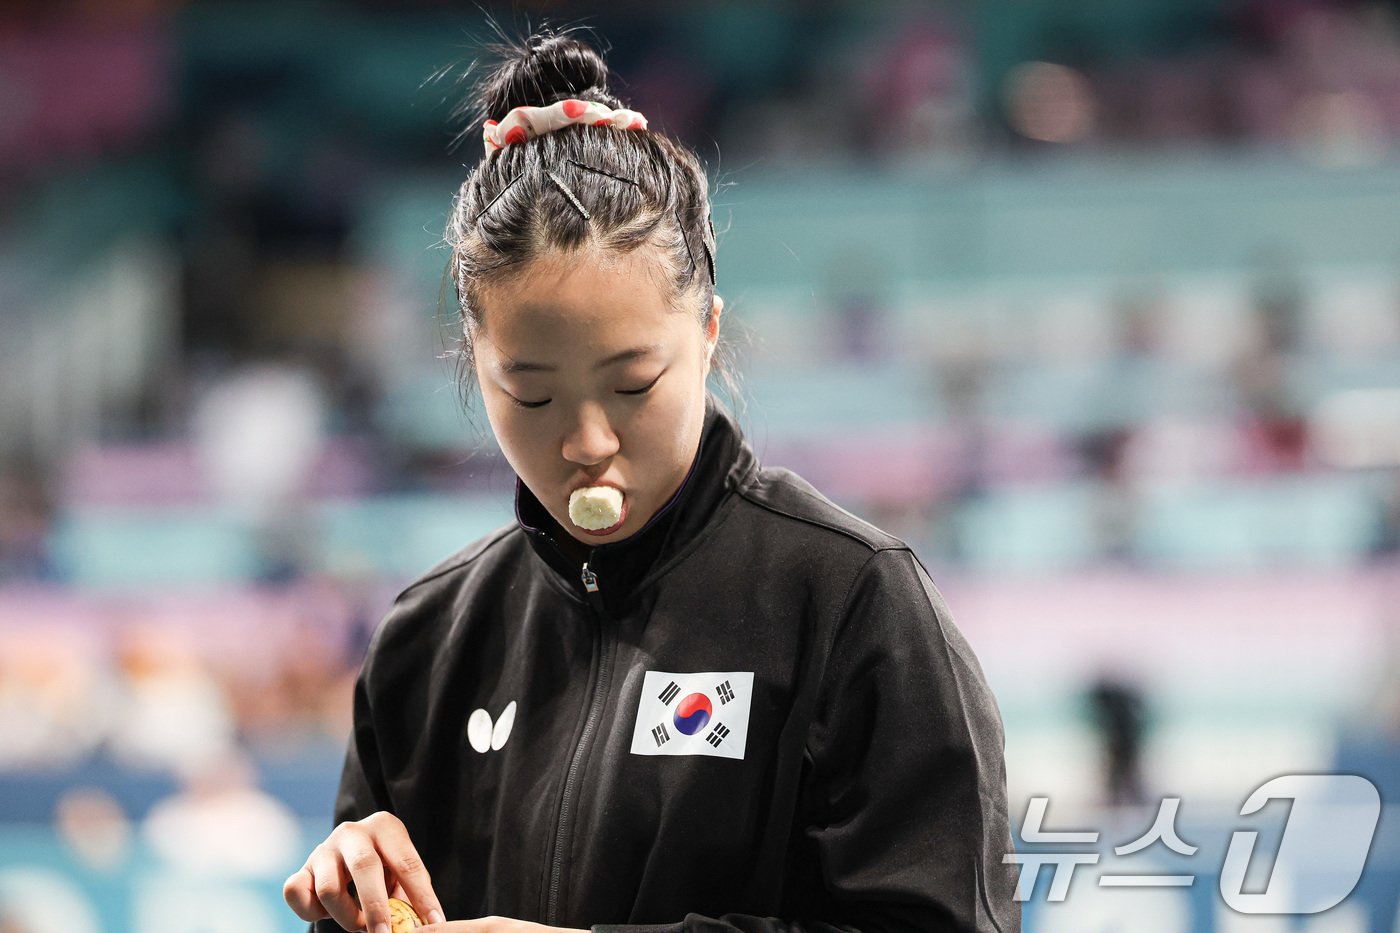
[447,31,738,398]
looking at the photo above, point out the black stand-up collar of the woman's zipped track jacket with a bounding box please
[515,394,757,611]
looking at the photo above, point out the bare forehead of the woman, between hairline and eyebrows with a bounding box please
[480,248,688,364]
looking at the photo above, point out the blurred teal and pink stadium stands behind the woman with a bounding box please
[0,0,1400,933]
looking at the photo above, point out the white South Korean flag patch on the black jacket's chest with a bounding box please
[631,671,753,758]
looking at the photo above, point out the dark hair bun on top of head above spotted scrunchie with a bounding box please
[480,34,622,120]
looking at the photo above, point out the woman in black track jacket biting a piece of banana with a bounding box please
[284,35,1019,933]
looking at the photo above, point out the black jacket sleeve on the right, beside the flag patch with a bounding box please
[592,548,1021,933]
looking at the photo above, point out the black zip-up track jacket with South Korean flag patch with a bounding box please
[314,398,1021,933]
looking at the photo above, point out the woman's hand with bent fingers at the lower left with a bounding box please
[281,810,450,933]
